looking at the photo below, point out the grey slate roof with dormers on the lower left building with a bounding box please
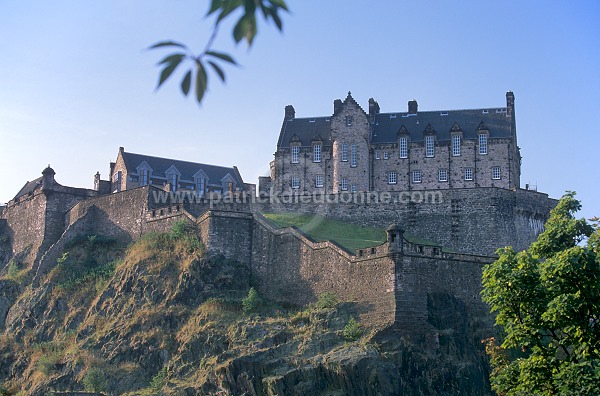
[122,151,244,186]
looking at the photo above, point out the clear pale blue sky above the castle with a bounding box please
[0,0,600,217]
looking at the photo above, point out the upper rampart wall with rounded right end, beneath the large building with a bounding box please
[253,188,556,255]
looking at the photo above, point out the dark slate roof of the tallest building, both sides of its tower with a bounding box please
[277,108,512,149]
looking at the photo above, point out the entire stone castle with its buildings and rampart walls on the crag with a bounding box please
[0,92,556,336]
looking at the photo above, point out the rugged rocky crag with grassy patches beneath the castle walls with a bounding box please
[0,224,491,396]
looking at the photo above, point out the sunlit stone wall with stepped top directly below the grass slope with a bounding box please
[252,215,395,325]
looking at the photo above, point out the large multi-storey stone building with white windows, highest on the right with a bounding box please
[259,92,521,195]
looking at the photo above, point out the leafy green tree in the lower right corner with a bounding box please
[482,192,600,395]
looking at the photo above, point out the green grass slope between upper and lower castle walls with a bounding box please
[263,213,386,251]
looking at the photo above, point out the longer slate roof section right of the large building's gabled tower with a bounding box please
[371,108,512,144]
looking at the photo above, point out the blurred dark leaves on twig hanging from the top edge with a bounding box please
[149,0,288,103]
